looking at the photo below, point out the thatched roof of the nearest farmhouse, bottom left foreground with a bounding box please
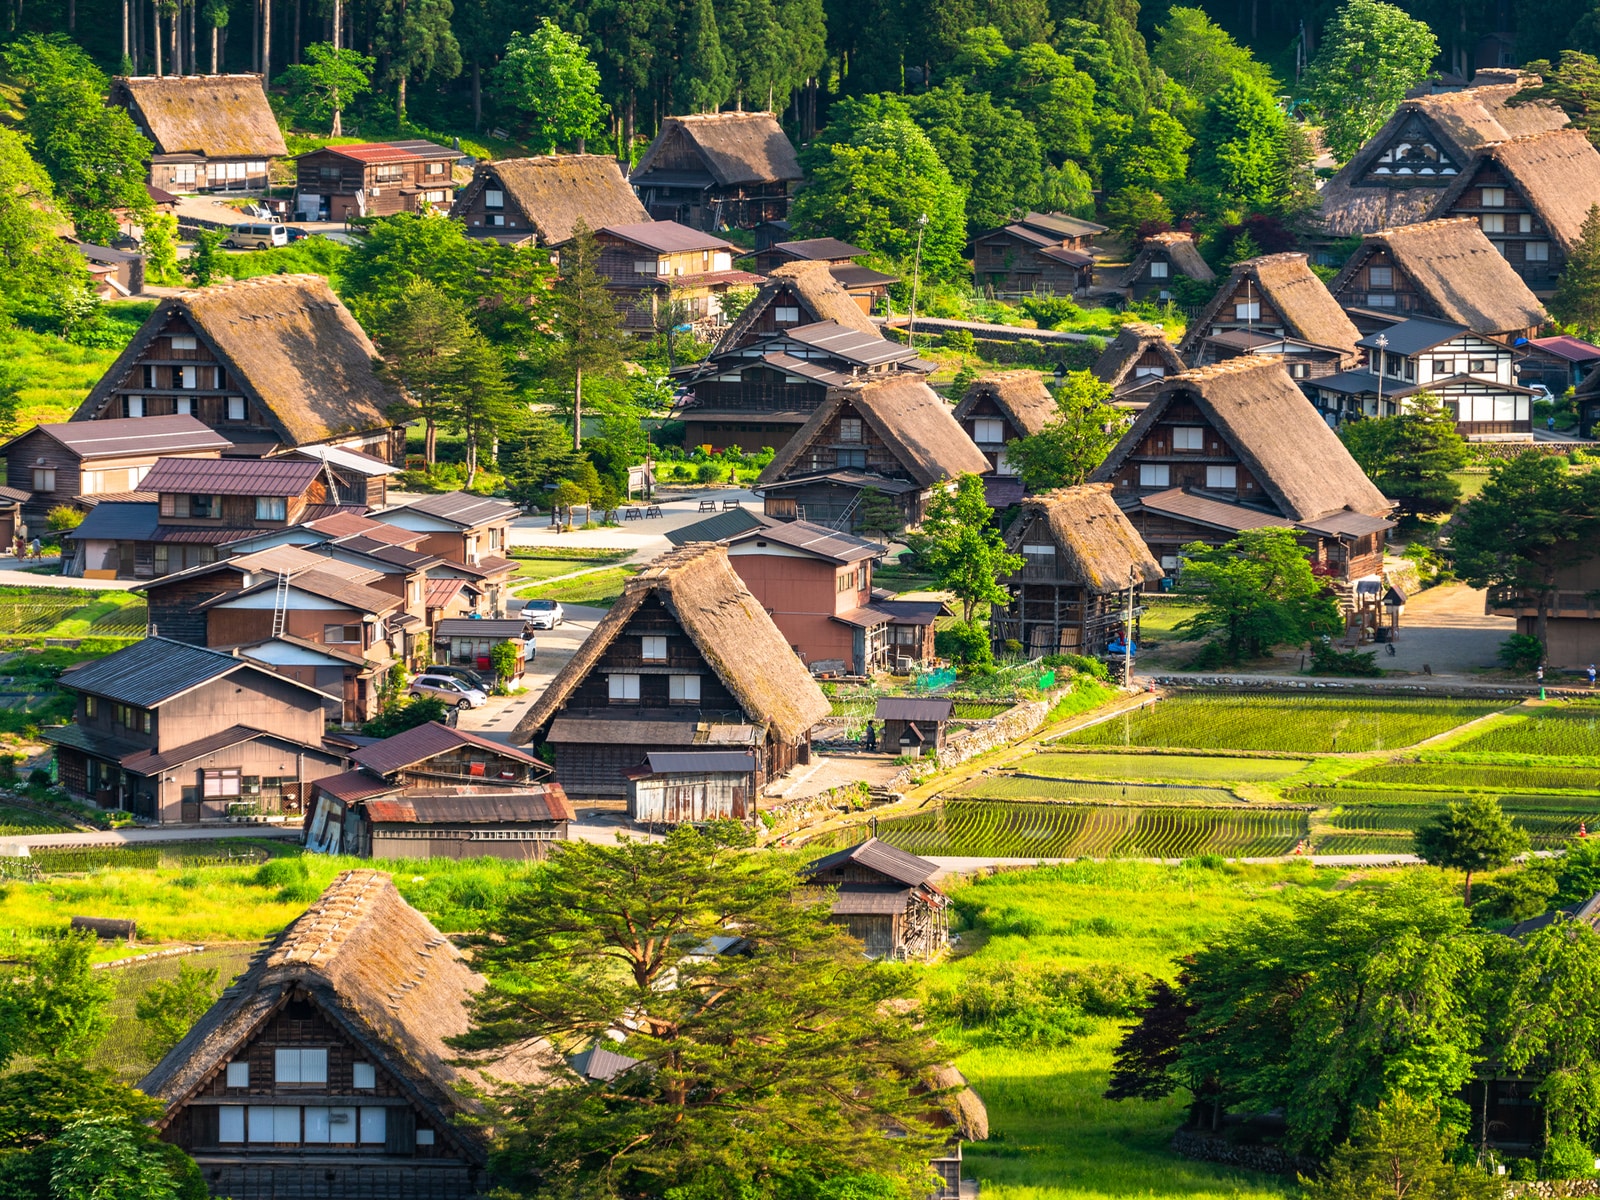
[139,870,547,1162]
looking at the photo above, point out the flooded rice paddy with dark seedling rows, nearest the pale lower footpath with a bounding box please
[813,800,1310,858]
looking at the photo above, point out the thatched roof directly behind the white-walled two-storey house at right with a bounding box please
[1331,219,1542,334]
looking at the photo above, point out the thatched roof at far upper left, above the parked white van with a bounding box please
[110,75,288,158]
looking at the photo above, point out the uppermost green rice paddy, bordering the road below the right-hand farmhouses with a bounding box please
[1062,696,1504,752]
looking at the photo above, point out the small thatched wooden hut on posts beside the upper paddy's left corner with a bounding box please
[989,483,1163,658]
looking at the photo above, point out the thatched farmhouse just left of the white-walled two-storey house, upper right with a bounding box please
[1178,254,1362,365]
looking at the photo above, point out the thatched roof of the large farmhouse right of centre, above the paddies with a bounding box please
[1093,354,1392,522]
